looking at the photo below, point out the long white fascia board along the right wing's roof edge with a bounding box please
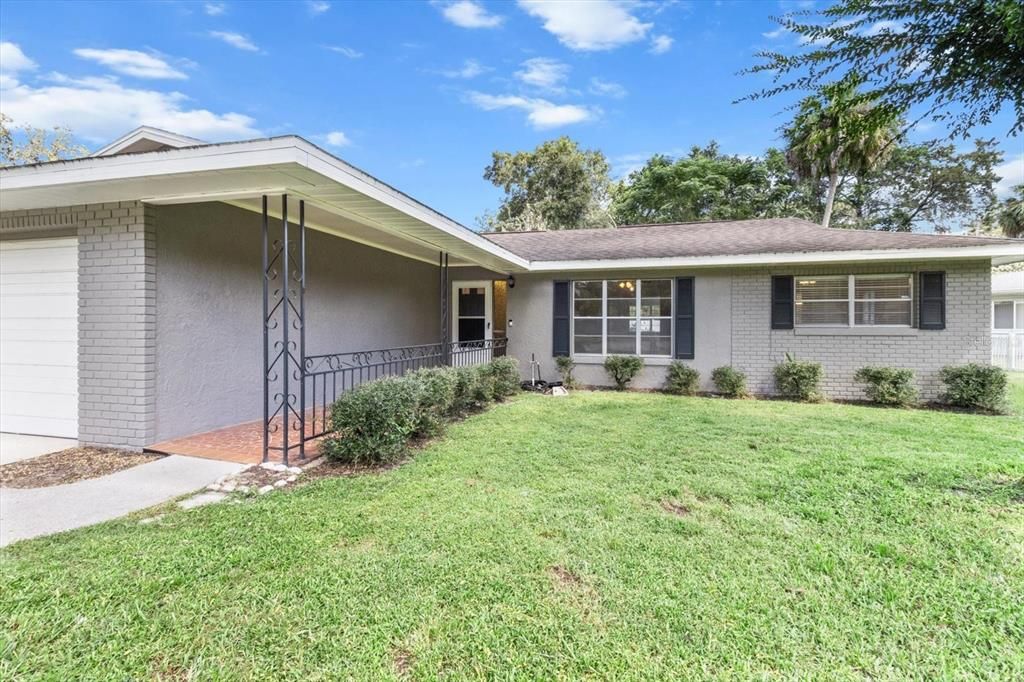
[529,244,1024,272]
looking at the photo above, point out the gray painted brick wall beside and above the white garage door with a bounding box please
[0,202,157,450]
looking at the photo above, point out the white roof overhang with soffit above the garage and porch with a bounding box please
[0,136,529,272]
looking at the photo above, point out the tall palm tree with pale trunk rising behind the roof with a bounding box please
[782,78,899,227]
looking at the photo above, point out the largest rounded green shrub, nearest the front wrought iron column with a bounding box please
[321,377,421,464]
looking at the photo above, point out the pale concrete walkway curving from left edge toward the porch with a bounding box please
[0,455,245,547]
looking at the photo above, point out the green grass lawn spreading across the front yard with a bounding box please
[0,391,1024,680]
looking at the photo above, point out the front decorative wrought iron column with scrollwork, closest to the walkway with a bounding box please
[263,195,306,464]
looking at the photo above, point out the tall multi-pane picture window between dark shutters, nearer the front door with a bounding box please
[572,280,672,357]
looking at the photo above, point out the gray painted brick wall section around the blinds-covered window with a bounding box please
[731,260,991,399]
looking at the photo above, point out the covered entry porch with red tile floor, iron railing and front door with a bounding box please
[147,193,516,464]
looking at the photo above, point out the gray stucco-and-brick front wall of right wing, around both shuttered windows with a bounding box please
[509,260,991,399]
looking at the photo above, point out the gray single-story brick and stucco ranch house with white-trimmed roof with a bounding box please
[0,128,1024,458]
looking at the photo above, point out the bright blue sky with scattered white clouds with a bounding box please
[0,0,1024,226]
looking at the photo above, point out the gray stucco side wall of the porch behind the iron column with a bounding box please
[156,204,440,441]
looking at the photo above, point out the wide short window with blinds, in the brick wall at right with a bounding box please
[796,274,913,327]
